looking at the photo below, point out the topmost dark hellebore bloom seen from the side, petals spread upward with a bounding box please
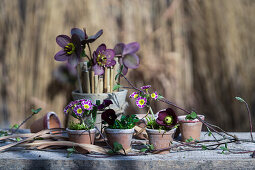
[71,28,103,46]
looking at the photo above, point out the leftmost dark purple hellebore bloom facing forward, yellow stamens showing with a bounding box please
[54,34,82,67]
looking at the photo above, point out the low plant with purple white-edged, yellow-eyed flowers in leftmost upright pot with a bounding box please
[64,99,112,130]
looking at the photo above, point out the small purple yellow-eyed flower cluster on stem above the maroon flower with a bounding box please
[129,85,159,108]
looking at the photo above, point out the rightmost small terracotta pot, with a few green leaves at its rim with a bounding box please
[178,115,205,142]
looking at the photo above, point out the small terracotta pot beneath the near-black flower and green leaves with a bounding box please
[105,129,134,152]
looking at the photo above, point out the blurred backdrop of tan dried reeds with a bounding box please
[0,0,255,131]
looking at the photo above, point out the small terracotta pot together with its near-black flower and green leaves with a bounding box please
[101,109,139,153]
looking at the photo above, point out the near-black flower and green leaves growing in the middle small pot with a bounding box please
[101,109,139,129]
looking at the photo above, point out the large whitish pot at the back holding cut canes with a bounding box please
[72,89,128,129]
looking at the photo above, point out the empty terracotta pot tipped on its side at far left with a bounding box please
[30,112,61,133]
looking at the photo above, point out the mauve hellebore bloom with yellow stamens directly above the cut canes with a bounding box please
[93,44,116,75]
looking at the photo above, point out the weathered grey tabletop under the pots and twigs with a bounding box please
[0,132,255,170]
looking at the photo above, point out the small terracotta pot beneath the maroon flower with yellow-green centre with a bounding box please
[146,129,176,154]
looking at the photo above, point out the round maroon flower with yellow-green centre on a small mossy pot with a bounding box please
[156,108,177,128]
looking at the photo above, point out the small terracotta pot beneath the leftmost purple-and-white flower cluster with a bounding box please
[66,128,96,145]
